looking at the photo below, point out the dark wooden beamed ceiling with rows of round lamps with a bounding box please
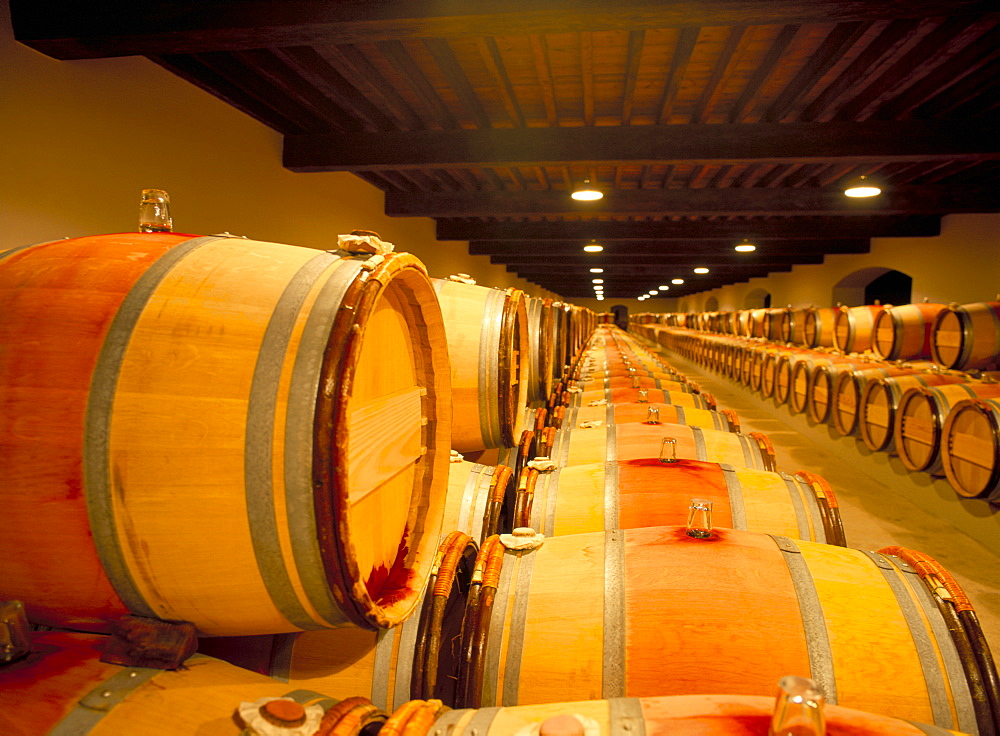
[10,0,1000,298]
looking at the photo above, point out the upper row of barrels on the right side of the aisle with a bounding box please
[632,302,1000,370]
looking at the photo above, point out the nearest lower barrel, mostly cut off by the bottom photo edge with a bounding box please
[422,685,955,736]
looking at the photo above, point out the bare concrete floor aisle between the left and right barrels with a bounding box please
[637,338,1000,661]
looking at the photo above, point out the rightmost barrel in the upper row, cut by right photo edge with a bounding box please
[931,301,1000,371]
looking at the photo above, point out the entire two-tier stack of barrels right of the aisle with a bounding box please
[633,302,1000,498]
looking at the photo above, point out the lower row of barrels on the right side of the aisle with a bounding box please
[636,316,1000,498]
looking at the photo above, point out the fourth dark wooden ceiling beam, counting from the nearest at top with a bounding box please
[437,215,941,243]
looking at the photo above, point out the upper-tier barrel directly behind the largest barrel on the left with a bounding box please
[434,279,530,452]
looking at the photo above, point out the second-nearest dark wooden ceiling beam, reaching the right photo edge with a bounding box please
[283,120,1000,172]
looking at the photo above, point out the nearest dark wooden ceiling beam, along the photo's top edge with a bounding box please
[10,0,996,59]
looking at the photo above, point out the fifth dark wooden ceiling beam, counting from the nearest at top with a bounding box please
[469,238,870,260]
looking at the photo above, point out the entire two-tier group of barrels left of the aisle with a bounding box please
[0,233,1000,736]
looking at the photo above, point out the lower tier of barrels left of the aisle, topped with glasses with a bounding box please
[0,324,996,735]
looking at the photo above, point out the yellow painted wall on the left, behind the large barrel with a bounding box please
[0,0,554,296]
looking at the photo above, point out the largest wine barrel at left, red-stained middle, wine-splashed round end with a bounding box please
[0,233,451,634]
